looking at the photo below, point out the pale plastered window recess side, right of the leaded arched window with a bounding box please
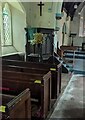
[12,4,26,52]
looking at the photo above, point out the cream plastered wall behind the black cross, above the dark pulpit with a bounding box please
[27,2,55,28]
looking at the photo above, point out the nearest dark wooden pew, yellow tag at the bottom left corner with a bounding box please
[0,88,31,120]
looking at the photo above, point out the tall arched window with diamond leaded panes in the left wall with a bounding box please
[2,3,12,46]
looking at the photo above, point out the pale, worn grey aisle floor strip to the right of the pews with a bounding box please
[49,74,85,120]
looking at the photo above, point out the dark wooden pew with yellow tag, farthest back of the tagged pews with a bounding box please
[2,59,62,99]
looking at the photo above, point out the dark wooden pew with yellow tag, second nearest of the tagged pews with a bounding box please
[2,70,51,118]
